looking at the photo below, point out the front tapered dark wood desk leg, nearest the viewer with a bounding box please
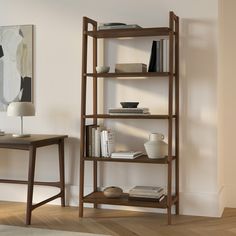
[26,146,36,225]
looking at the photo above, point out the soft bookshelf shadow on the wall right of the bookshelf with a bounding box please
[180,19,217,195]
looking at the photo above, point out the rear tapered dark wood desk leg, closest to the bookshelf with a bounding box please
[58,139,65,207]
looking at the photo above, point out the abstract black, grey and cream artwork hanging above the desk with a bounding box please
[0,25,33,111]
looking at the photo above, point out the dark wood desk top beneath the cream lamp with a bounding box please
[0,134,68,147]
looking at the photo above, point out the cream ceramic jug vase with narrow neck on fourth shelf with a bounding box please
[144,133,168,159]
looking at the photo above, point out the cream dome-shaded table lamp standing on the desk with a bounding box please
[7,102,35,138]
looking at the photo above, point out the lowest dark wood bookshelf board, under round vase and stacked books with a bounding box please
[83,192,177,208]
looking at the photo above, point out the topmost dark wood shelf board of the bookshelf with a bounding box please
[84,27,174,38]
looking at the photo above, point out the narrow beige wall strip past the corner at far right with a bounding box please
[218,0,236,207]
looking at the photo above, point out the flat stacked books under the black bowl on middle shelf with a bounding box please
[108,108,150,115]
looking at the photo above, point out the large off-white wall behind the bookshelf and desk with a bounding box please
[0,0,220,216]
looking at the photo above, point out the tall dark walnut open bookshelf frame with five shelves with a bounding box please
[79,12,179,224]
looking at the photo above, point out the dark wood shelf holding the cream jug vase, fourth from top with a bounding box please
[84,155,176,164]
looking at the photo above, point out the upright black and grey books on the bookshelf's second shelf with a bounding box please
[148,39,169,72]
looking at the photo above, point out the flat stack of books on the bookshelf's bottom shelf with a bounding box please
[129,186,165,202]
